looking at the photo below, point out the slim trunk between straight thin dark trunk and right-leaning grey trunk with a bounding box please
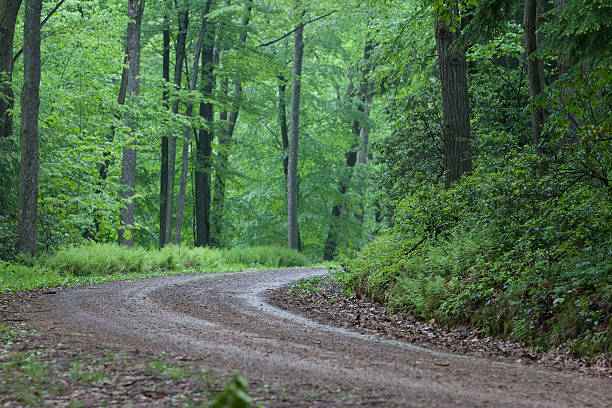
[164,4,189,245]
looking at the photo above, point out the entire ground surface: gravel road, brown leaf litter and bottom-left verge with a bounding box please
[0,270,612,407]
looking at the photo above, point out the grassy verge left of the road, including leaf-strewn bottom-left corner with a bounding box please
[0,244,323,408]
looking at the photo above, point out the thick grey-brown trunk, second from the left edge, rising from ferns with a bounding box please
[17,0,42,256]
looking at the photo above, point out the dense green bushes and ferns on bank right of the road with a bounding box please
[343,157,612,355]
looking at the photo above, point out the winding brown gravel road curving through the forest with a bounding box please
[26,269,612,407]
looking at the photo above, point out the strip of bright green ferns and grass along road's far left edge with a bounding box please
[0,244,309,294]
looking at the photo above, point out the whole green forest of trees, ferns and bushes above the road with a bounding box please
[0,0,612,355]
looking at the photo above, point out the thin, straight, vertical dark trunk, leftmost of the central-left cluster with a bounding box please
[159,12,170,249]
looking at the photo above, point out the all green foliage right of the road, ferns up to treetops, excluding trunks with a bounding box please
[342,0,612,354]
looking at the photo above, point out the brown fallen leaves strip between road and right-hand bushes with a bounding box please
[268,279,612,378]
